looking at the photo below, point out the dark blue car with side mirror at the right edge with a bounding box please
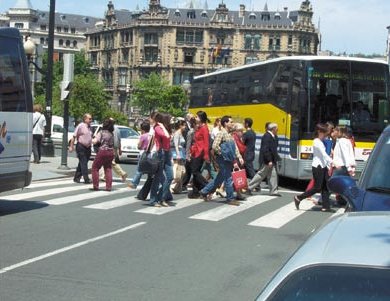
[329,126,390,211]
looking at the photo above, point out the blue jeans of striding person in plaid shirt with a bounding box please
[201,156,234,201]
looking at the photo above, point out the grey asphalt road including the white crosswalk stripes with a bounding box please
[0,158,342,301]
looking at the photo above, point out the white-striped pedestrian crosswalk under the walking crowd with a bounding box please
[0,179,343,229]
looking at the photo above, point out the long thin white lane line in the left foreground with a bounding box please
[0,222,146,274]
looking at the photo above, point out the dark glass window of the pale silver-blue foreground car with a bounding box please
[267,266,390,301]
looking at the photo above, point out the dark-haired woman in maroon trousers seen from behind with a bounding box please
[92,118,114,191]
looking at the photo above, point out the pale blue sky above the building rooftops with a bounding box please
[0,0,390,55]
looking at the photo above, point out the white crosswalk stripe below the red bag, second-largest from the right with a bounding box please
[189,195,275,222]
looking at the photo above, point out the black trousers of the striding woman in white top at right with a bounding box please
[298,165,330,209]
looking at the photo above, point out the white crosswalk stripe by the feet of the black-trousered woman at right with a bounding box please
[248,201,314,229]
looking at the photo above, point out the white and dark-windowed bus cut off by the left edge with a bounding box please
[0,28,33,192]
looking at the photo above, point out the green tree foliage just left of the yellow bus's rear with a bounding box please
[132,73,188,116]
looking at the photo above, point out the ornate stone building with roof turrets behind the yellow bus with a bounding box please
[86,0,319,111]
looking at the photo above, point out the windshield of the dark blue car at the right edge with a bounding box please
[364,134,390,193]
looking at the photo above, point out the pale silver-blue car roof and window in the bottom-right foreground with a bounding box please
[257,212,390,301]
